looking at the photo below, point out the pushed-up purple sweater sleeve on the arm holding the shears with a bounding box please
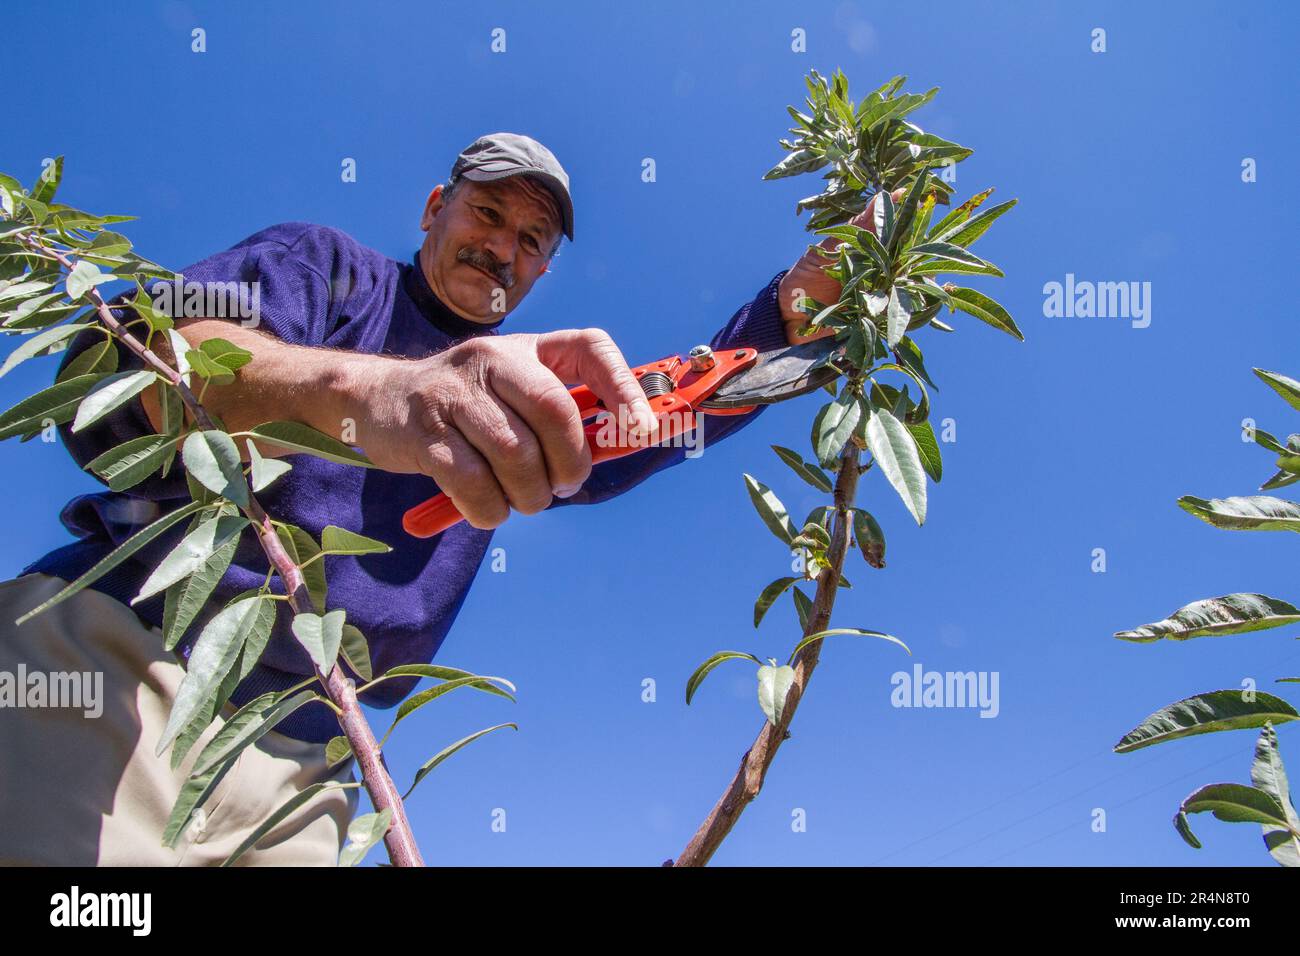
[59,222,351,501]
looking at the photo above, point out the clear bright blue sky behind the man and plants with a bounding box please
[0,3,1300,865]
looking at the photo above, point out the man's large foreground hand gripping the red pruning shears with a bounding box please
[348,329,655,528]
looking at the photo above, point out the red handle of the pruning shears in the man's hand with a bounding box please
[402,349,758,537]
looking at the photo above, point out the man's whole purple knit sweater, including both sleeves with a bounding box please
[22,222,785,743]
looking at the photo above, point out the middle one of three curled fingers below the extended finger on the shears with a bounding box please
[455,385,554,515]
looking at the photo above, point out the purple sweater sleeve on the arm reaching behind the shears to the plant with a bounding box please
[551,271,788,507]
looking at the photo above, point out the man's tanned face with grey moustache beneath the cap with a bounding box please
[420,174,560,323]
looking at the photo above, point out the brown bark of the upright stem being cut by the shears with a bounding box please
[664,438,862,866]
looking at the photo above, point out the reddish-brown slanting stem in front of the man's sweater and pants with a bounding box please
[21,235,424,866]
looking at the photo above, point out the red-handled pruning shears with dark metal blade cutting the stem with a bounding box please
[402,337,844,537]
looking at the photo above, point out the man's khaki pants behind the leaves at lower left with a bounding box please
[0,574,358,866]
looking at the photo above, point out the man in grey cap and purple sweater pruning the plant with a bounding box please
[0,133,870,865]
